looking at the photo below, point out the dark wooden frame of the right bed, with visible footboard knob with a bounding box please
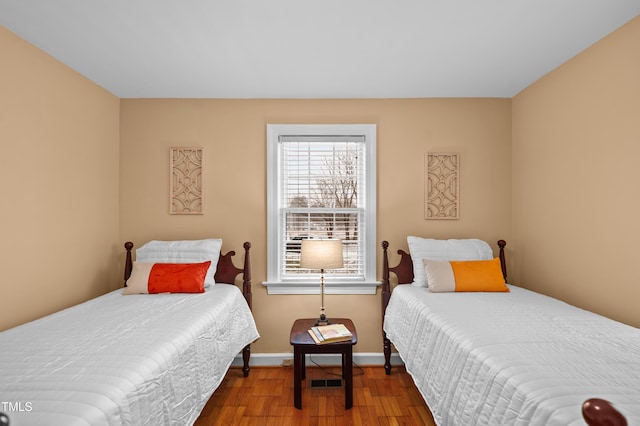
[381,240,627,426]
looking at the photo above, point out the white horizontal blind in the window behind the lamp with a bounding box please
[279,135,366,279]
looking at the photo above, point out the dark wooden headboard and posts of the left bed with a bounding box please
[124,241,252,377]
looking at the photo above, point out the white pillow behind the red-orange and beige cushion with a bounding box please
[136,238,222,287]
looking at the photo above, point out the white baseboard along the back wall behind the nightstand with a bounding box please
[231,352,404,367]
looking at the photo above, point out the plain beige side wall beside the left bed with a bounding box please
[0,26,121,330]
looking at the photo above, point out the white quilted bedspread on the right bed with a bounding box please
[384,285,640,426]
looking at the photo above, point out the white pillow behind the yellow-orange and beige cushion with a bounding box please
[407,236,493,287]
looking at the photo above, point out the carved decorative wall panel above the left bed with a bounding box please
[169,148,203,214]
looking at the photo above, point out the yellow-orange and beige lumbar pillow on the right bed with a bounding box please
[422,258,509,293]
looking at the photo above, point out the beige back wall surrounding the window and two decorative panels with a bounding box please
[120,99,511,353]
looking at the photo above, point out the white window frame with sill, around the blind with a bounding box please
[262,124,380,294]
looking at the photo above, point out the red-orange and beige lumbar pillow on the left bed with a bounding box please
[123,260,211,294]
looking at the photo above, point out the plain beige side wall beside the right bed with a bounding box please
[512,17,640,327]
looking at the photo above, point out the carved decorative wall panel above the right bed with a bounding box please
[424,152,460,219]
